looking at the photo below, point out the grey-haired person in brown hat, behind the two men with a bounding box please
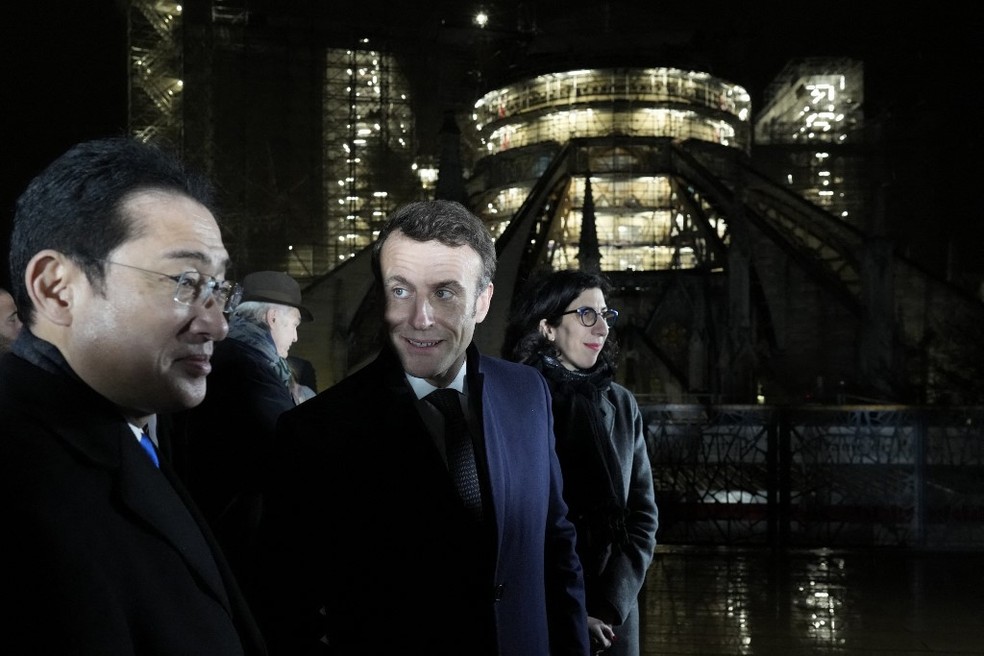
[175,271,314,592]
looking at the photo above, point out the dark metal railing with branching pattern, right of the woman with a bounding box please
[642,404,984,550]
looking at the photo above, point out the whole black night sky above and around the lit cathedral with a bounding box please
[0,0,984,285]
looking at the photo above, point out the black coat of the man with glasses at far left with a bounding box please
[0,353,265,656]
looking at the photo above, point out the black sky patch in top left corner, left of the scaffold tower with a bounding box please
[0,0,127,287]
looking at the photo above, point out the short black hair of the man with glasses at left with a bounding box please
[10,137,214,325]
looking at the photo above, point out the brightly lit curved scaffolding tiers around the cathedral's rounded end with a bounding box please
[472,68,751,271]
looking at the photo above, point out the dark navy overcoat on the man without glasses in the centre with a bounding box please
[258,346,588,656]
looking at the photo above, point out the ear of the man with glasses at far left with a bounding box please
[24,249,79,326]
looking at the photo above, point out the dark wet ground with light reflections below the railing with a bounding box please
[640,546,984,656]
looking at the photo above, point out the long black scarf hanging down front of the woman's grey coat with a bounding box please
[533,354,628,577]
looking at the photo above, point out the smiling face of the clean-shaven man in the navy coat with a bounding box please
[379,232,492,387]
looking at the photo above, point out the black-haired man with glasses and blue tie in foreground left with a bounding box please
[0,138,265,656]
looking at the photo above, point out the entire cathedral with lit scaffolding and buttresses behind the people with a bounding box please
[130,0,984,403]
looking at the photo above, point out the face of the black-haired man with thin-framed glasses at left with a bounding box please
[59,191,229,420]
